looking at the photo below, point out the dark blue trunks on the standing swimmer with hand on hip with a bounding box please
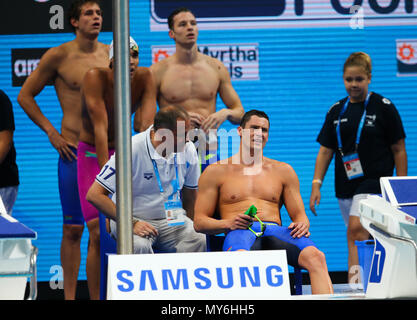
[58,147,84,225]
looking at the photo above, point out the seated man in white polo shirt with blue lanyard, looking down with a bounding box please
[86,106,206,253]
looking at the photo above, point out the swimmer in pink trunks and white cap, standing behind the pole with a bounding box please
[77,38,156,299]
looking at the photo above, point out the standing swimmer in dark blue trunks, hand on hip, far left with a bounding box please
[17,0,109,300]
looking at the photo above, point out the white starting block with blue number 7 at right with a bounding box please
[359,177,417,299]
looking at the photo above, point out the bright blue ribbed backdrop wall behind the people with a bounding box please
[0,1,417,281]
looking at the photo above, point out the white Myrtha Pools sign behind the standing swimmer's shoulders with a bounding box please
[152,43,259,80]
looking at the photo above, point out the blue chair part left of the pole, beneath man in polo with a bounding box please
[99,212,117,300]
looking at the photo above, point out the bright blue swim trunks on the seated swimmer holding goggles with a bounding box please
[223,221,316,267]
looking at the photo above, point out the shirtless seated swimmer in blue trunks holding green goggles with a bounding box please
[194,110,333,294]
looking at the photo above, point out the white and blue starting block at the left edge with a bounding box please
[0,198,38,300]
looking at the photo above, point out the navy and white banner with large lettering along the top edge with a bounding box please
[150,0,417,31]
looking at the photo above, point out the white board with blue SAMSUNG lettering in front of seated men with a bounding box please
[107,250,291,300]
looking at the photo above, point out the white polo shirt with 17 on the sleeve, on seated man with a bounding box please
[96,126,200,219]
